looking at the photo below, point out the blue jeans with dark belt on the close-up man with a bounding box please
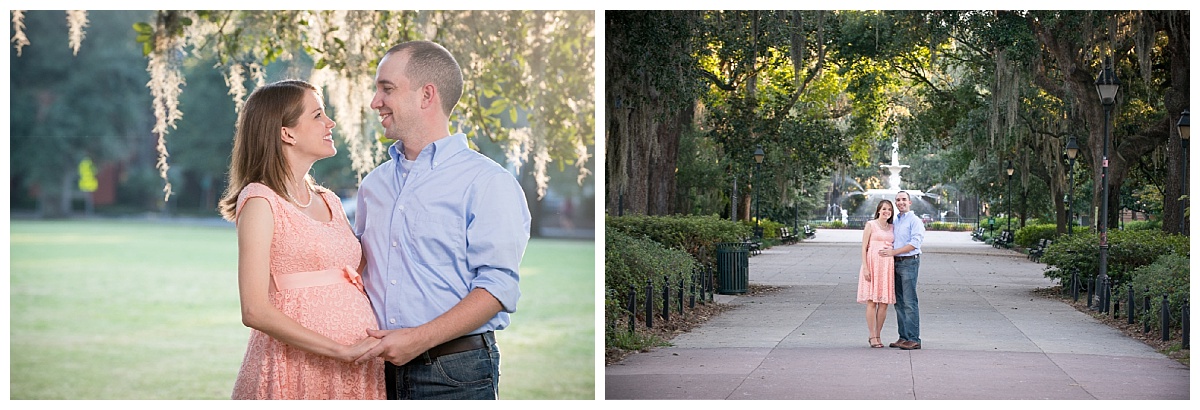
[384,343,500,400]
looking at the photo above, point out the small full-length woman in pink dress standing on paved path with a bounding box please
[858,199,896,348]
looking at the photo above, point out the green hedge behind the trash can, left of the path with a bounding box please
[605,215,754,266]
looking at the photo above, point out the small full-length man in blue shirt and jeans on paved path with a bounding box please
[880,191,925,350]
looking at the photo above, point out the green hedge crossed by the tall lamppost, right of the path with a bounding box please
[1042,230,1188,285]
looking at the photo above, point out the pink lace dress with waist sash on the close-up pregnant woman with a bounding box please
[233,183,386,399]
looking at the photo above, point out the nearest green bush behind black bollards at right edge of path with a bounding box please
[1114,254,1192,330]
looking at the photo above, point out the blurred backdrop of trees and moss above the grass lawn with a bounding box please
[10,11,595,237]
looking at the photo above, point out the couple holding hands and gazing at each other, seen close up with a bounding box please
[220,41,530,399]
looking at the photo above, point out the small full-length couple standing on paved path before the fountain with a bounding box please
[858,191,925,350]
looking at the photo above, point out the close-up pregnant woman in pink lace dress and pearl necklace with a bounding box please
[220,80,385,399]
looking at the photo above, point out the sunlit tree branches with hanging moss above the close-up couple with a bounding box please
[13,11,595,205]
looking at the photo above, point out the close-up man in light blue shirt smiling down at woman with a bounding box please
[354,41,529,399]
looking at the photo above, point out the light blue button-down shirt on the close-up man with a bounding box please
[354,133,529,333]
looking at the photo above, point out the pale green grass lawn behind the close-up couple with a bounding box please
[10,221,596,399]
